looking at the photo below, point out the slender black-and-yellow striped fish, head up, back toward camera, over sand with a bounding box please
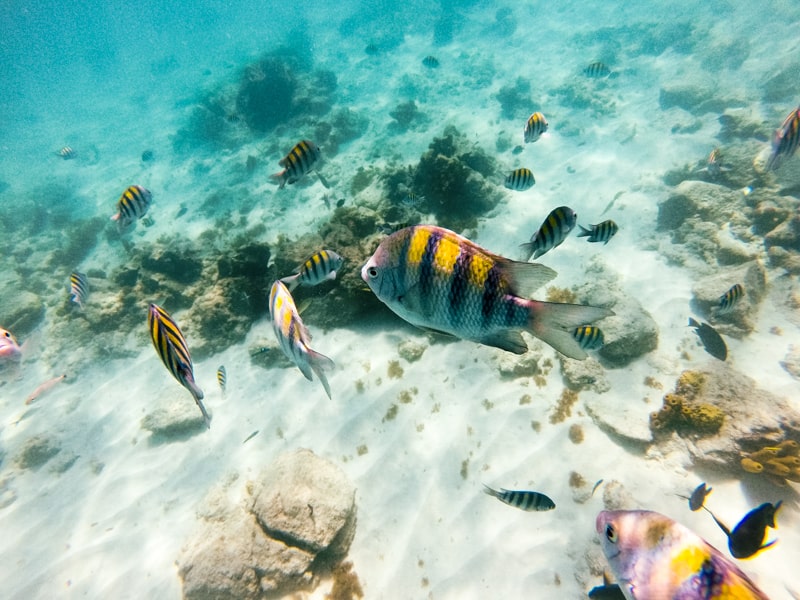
[147,304,211,428]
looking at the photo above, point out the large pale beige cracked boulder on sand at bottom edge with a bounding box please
[178,449,356,600]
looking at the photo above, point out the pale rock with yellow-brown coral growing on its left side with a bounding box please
[651,361,800,475]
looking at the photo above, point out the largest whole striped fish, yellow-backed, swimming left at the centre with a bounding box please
[361,225,614,359]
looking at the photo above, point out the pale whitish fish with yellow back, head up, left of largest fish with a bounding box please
[269,281,335,398]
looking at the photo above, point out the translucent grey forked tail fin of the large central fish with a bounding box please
[528,300,614,360]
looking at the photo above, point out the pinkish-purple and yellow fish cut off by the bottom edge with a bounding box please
[595,510,769,600]
